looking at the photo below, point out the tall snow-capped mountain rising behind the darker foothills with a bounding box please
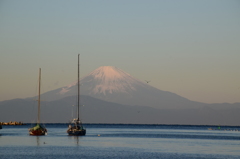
[38,66,202,109]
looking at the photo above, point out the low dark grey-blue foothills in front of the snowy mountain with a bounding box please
[0,96,240,125]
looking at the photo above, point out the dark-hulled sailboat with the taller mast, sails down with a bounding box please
[67,54,86,136]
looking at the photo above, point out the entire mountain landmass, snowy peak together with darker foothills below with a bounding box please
[0,66,240,125]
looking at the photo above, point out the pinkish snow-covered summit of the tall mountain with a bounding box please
[60,66,140,96]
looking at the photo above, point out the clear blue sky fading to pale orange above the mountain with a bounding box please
[0,0,240,103]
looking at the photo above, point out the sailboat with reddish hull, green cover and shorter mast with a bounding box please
[28,68,47,136]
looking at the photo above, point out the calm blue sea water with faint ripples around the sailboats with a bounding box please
[0,124,240,159]
